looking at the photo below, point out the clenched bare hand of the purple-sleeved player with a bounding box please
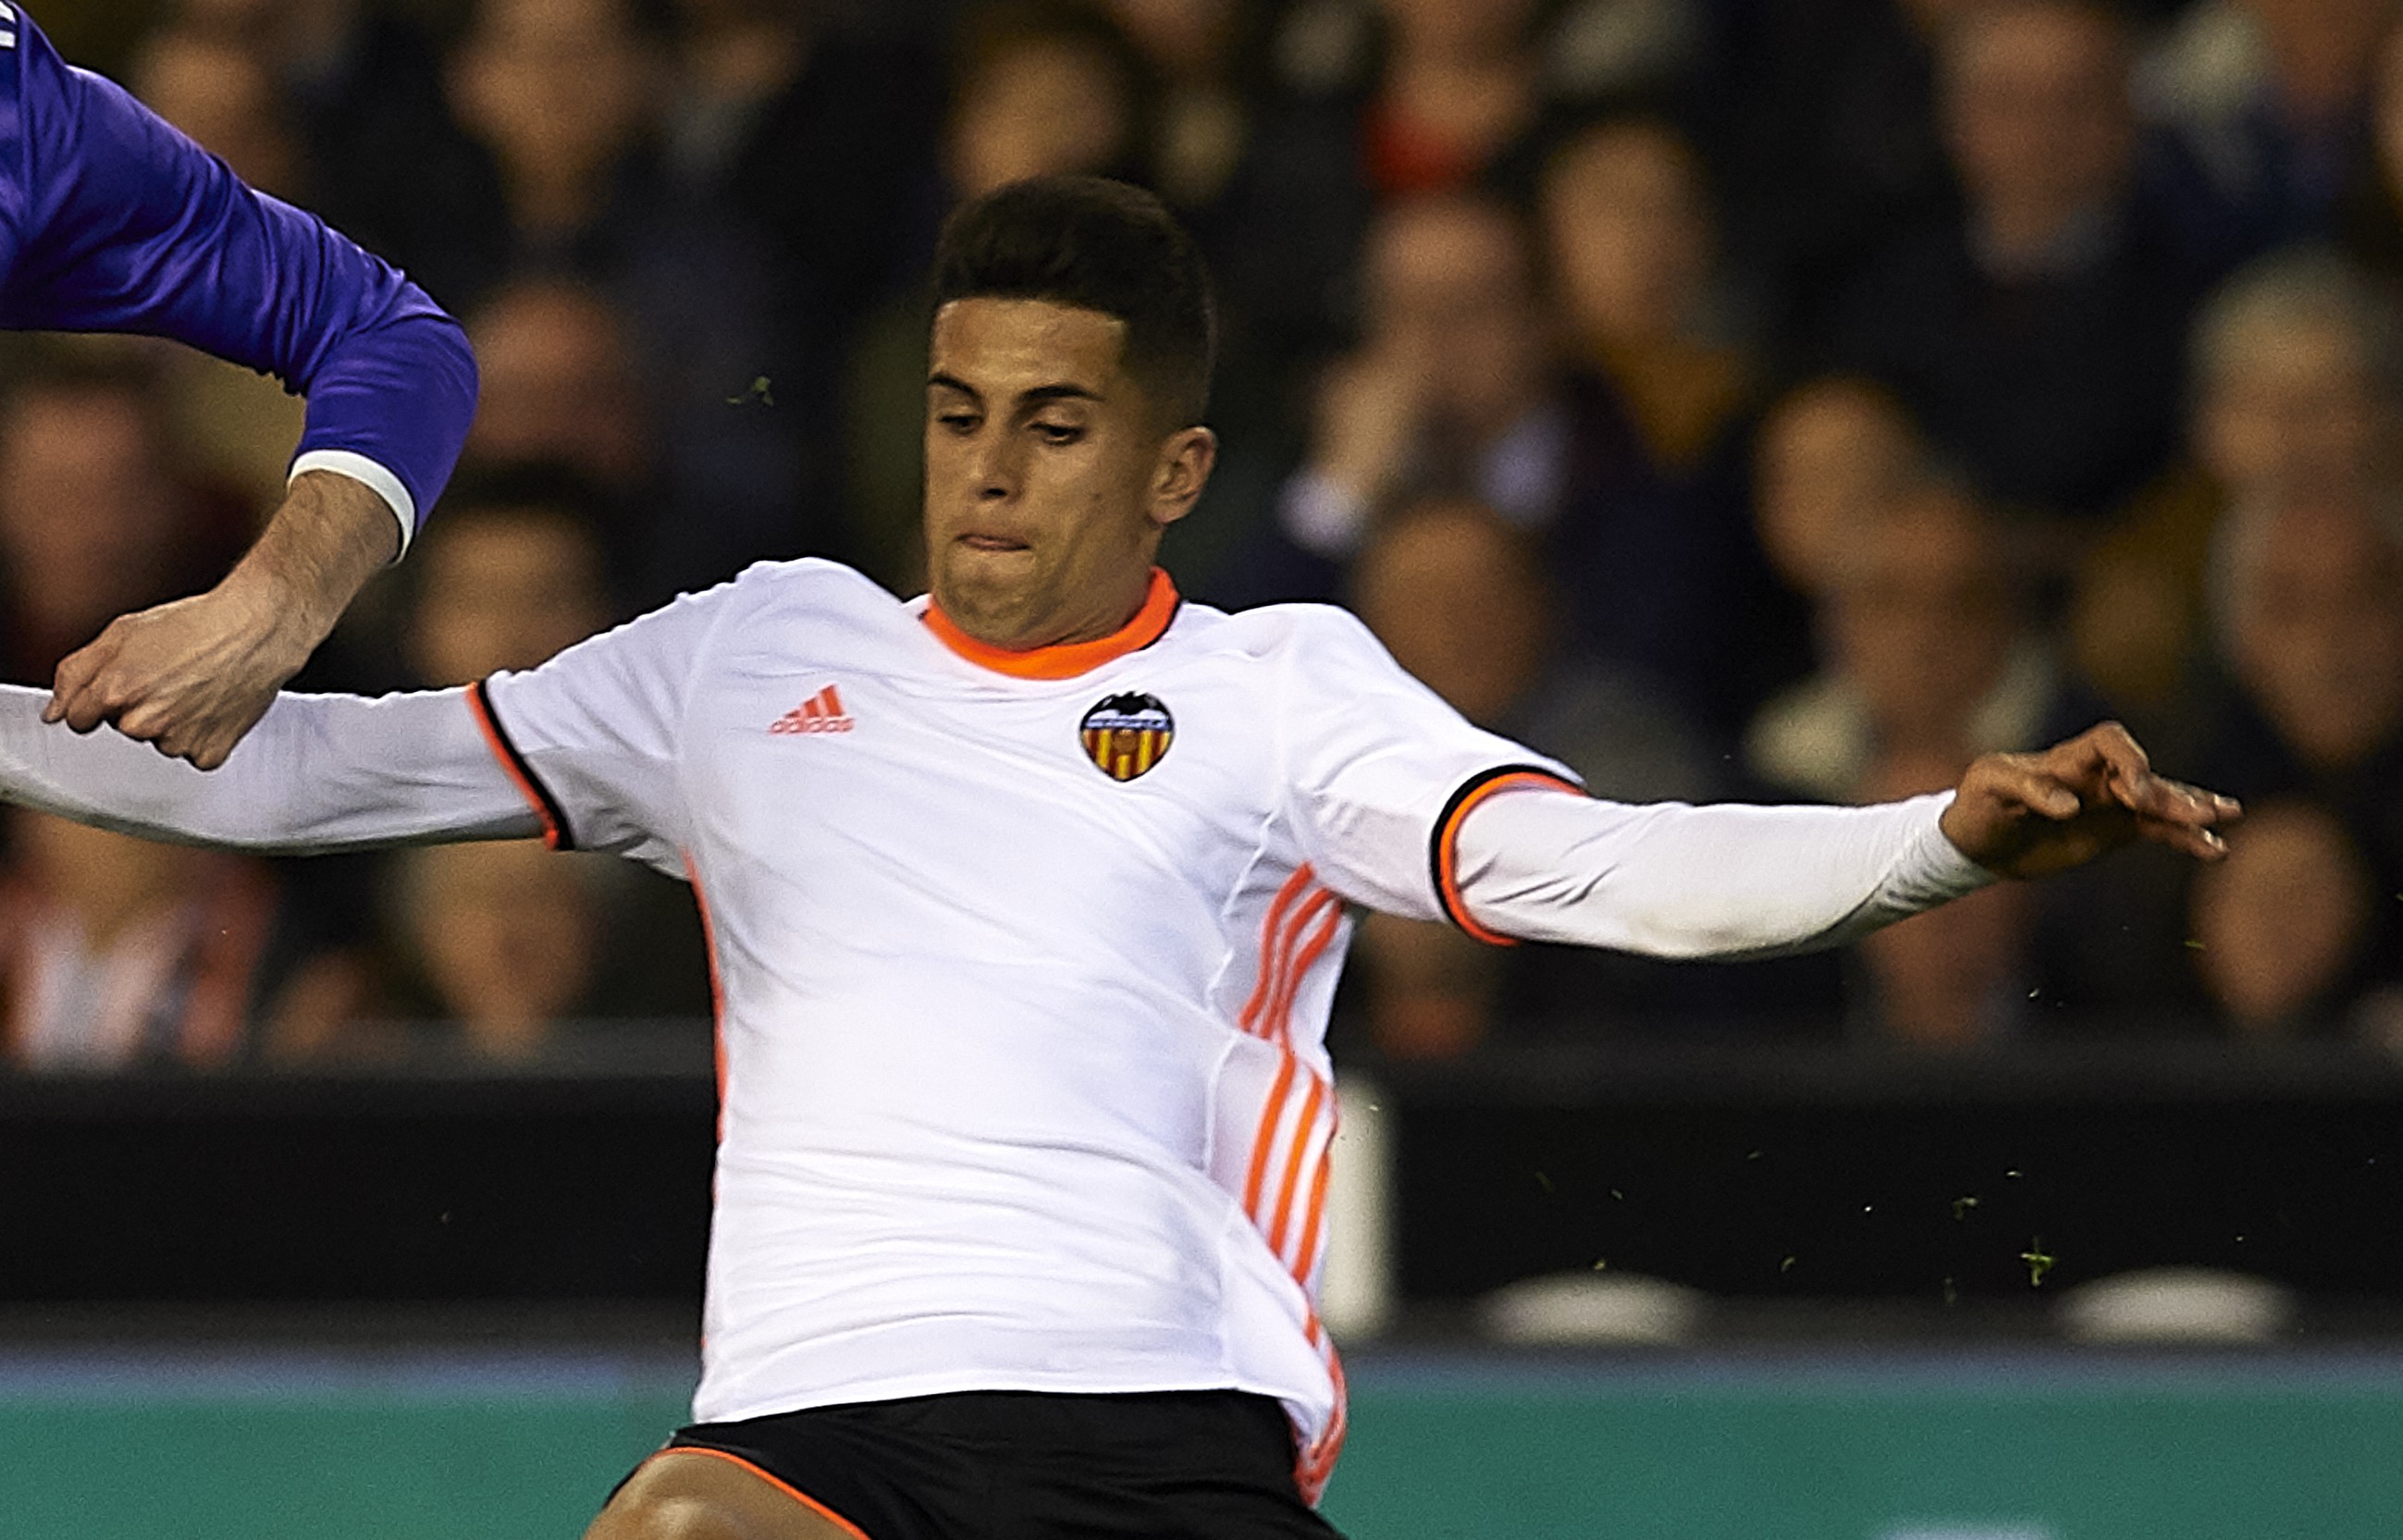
[41,576,310,769]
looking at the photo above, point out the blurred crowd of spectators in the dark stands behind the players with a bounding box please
[0,0,2403,1069]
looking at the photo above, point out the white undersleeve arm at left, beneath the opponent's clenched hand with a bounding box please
[0,684,541,856]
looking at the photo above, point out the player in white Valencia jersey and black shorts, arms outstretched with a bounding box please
[0,178,2235,1540]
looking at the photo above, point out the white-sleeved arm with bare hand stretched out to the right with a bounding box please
[1447,723,2237,958]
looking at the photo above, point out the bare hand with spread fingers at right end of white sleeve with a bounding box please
[1944,721,2242,877]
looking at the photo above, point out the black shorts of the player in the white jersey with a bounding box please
[648,1391,1338,1540]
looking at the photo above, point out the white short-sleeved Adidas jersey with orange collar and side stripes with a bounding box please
[486,562,1562,1487]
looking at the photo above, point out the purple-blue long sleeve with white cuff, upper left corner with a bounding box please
[0,5,475,540]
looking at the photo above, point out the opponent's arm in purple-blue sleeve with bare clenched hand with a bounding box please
[0,5,475,769]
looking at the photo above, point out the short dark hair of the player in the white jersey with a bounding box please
[935,176,1218,425]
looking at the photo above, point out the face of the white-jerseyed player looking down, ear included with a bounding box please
[925,298,1216,648]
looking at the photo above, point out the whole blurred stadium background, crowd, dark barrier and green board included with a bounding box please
[0,0,2403,1540]
